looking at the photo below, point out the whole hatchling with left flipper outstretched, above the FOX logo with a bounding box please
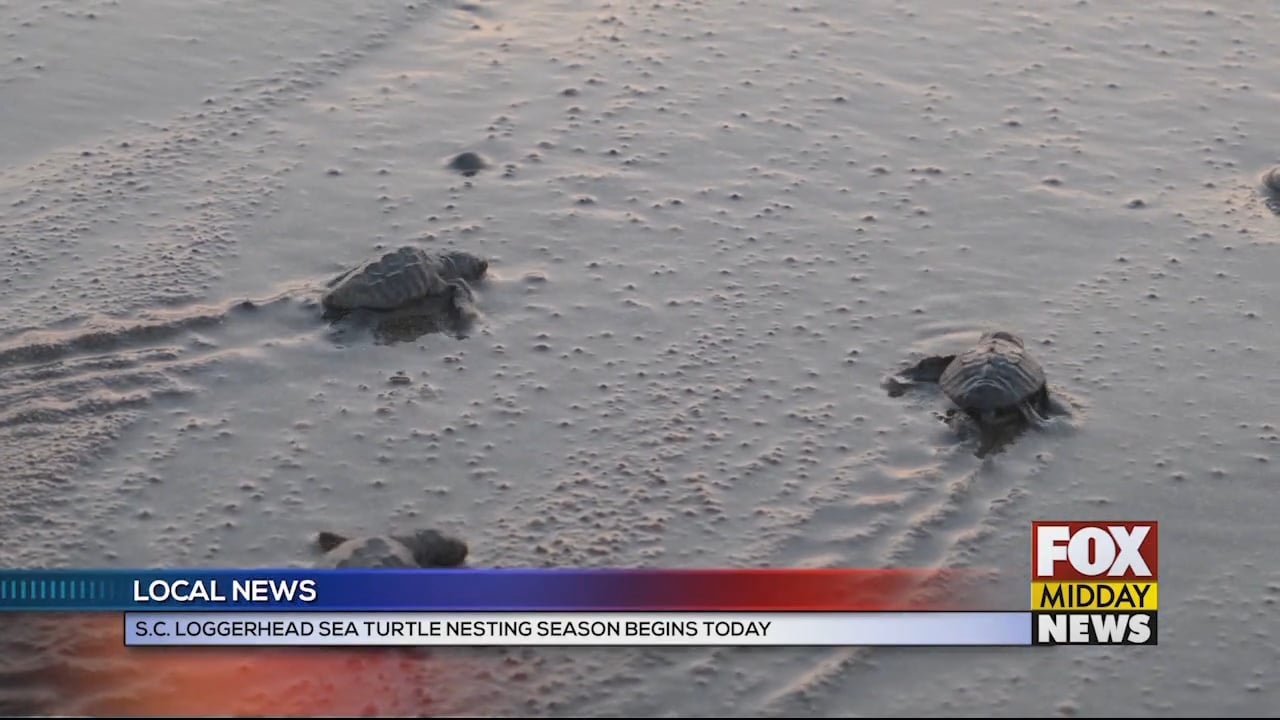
[886,331,1070,455]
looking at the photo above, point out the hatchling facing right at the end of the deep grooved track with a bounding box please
[321,245,489,315]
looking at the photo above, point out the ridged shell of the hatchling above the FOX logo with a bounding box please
[938,331,1044,411]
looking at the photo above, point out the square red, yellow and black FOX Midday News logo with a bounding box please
[1032,521,1160,646]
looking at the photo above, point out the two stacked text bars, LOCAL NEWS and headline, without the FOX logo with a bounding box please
[0,568,1030,646]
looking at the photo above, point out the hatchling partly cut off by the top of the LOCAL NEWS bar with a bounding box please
[316,528,468,568]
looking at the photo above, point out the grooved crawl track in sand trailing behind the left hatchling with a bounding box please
[0,292,296,520]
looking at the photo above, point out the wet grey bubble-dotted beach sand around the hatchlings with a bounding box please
[0,0,1280,716]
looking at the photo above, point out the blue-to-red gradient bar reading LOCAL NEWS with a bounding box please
[0,568,991,612]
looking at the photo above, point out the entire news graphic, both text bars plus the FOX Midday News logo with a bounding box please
[0,520,1158,647]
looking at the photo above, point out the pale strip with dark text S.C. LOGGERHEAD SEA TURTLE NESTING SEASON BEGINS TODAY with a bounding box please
[124,611,1032,646]
